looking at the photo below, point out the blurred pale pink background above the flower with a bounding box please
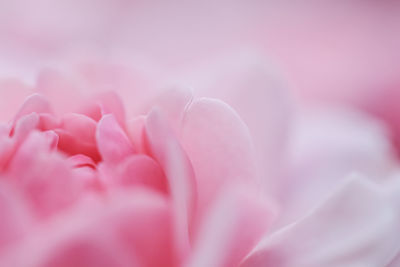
[0,0,400,100]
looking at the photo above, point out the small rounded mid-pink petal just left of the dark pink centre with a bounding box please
[7,131,81,216]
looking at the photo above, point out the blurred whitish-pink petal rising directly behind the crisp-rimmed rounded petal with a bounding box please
[187,56,293,194]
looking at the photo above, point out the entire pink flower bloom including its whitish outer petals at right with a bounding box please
[0,62,400,267]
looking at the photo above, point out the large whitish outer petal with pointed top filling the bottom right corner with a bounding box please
[241,177,400,267]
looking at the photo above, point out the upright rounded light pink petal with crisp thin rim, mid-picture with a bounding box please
[181,98,257,220]
